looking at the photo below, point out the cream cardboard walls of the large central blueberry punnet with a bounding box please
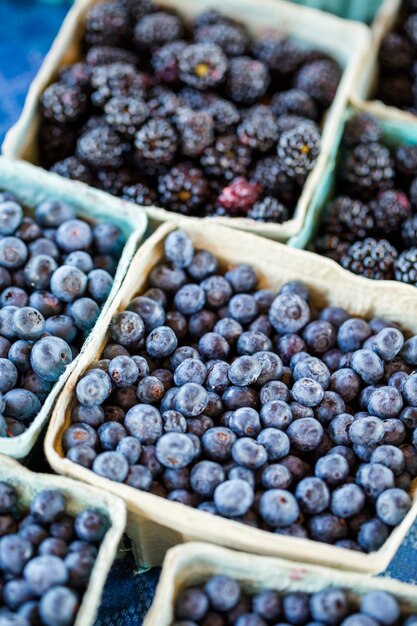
[45,220,417,573]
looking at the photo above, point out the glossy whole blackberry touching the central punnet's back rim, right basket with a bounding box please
[340,237,398,280]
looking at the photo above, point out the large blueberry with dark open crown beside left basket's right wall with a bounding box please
[30,337,72,382]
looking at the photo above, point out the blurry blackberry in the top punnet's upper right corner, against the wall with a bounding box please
[295,61,342,109]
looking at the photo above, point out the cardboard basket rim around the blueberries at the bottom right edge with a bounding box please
[143,543,417,626]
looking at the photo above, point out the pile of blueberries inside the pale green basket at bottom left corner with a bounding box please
[0,482,109,626]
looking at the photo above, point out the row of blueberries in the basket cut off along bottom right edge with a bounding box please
[172,575,417,626]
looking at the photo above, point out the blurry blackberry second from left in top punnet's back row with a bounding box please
[134,11,184,48]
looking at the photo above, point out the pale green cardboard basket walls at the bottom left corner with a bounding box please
[0,454,126,626]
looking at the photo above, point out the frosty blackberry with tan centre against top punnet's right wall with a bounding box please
[277,124,320,177]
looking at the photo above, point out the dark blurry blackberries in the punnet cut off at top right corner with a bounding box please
[375,0,417,115]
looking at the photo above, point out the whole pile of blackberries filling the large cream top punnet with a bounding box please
[39,0,341,223]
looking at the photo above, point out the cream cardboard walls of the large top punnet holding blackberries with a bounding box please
[3,0,370,241]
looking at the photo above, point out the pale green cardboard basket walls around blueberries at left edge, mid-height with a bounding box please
[0,157,147,459]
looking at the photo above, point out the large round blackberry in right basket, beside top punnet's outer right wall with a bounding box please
[342,142,394,196]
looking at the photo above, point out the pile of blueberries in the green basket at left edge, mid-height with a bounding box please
[0,192,125,437]
